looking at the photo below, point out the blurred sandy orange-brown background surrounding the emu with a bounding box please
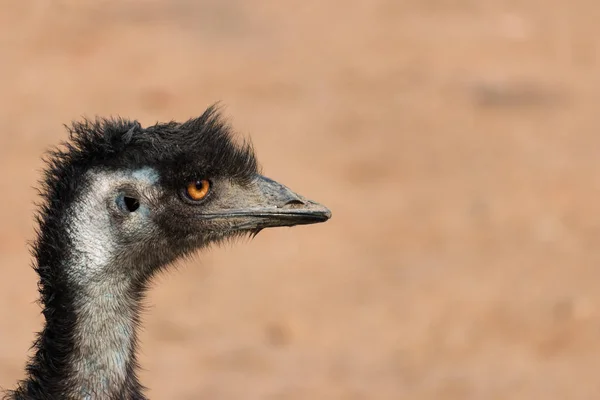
[0,0,600,400]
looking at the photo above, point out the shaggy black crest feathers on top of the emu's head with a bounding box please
[56,106,258,189]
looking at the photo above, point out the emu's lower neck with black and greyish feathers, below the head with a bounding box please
[20,233,144,400]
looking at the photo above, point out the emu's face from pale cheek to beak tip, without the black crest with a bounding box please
[78,166,331,278]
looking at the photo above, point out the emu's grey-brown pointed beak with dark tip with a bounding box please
[202,175,331,233]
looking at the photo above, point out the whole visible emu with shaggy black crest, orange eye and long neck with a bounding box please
[3,105,331,400]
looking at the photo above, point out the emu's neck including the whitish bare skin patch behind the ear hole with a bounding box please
[15,173,149,400]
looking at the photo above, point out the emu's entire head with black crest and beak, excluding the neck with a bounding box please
[41,108,331,283]
